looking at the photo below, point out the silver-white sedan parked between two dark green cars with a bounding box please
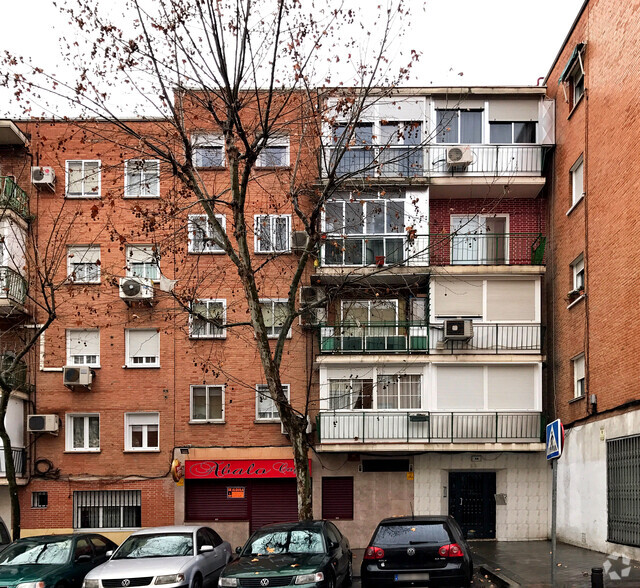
[82,525,231,588]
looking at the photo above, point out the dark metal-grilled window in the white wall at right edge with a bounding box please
[607,435,640,547]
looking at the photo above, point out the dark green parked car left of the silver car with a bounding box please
[0,533,117,588]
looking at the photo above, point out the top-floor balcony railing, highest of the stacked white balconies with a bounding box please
[336,144,544,178]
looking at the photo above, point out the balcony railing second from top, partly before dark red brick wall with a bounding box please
[322,233,546,266]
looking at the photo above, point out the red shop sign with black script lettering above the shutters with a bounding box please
[185,459,311,480]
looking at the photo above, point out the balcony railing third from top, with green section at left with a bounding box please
[318,322,543,354]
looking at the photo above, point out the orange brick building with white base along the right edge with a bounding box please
[546,0,640,558]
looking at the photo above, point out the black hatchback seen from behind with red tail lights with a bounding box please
[361,516,473,588]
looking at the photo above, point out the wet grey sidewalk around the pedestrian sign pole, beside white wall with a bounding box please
[469,541,640,588]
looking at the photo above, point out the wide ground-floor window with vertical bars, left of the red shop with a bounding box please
[73,490,142,529]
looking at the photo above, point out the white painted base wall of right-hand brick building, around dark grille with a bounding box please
[558,411,640,560]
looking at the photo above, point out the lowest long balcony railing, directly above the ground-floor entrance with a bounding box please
[317,410,544,443]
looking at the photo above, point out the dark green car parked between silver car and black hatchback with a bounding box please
[218,521,353,588]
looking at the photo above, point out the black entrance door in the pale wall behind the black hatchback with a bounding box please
[449,472,496,539]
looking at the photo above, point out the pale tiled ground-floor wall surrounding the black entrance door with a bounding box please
[414,453,551,541]
